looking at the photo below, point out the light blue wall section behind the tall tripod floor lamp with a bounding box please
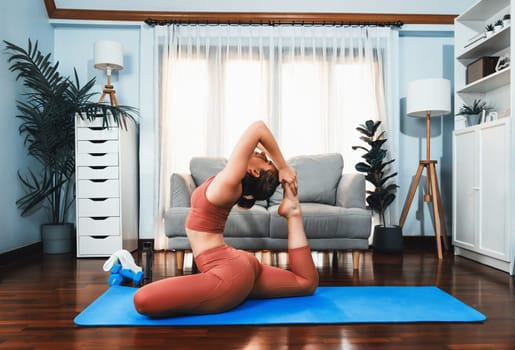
[397,29,454,236]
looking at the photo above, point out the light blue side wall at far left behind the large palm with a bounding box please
[0,0,54,253]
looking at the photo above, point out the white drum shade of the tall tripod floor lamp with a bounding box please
[406,79,451,117]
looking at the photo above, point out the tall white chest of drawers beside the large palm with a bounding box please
[75,118,138,257]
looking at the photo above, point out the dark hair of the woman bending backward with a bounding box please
[238,170,279,209]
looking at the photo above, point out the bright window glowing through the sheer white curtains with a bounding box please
[165,43,379,171]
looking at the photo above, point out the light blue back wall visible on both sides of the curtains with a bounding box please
[54,21,454,242]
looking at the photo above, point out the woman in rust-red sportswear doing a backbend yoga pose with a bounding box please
[134,122,318,317]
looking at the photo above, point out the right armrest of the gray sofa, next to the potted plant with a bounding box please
[336,173,366,209]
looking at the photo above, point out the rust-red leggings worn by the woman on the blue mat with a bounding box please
[134,245,318,317]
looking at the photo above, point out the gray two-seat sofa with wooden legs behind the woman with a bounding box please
[164,153,372,269]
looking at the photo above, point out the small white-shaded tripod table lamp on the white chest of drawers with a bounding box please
[95,40,123,107]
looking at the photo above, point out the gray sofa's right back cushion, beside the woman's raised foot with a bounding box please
[270,153,343,205]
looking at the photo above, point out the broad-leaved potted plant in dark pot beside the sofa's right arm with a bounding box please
[352,120,403,253]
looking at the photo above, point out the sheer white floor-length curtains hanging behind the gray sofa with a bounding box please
[155,25,398,248]
